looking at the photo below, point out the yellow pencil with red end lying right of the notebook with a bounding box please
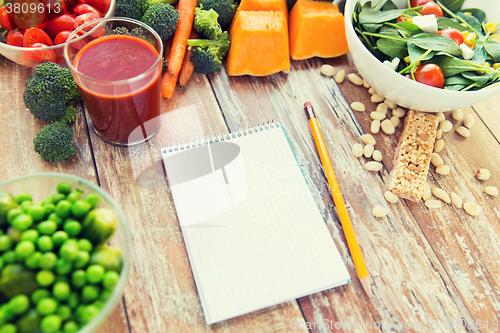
[304,102,372,297]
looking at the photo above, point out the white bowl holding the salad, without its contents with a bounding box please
[345,0,500,112]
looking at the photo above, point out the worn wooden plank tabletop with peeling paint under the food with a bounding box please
[0,52,500,333]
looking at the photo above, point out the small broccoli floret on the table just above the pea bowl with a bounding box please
[33,121,76,162]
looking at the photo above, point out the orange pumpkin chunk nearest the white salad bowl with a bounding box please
[288,0,349,60]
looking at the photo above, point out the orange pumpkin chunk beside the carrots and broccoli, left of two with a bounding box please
[226,11,290,76]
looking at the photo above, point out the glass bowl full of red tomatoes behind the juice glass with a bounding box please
[0,0,116,67]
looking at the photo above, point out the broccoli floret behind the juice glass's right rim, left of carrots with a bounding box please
[141,3,179,41]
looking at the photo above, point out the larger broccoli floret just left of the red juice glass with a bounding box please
[23,62,81,123]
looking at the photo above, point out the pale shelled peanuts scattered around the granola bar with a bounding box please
[321,65,498,217]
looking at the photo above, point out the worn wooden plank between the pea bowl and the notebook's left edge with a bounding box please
[86,74,302,332]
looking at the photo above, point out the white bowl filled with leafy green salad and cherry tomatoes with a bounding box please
[345,0,500,112]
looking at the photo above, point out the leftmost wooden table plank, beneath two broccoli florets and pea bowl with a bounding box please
[0,58,128,333]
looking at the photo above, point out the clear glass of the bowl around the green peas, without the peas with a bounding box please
[0,173,131,333]
